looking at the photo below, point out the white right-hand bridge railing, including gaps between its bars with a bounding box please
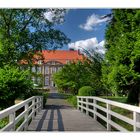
[77,96,140,131]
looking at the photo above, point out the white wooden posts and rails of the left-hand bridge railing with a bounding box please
[0,96,42,131]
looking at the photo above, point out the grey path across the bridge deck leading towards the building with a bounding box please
[28,93,106,131]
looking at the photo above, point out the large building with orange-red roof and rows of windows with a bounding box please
[20,50,84,88]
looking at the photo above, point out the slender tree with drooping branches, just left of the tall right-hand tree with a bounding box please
[83,49,105,95]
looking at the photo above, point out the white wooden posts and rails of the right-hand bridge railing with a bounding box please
[77,96,140,131]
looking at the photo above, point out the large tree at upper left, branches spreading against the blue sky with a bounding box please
[0,9,70,66]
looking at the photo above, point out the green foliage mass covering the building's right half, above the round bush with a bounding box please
[53,51,103,95]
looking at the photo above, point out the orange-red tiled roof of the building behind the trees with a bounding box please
[21,50,84,64]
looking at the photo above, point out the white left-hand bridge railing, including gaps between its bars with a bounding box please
[0,96,43,131]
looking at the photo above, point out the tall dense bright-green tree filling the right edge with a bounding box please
[102,9,140,103]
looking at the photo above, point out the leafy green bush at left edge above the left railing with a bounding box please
[0,65,33,108]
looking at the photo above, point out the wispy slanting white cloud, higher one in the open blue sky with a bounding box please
[79,14,110,31]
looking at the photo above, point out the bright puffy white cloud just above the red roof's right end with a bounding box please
[68,37,105,54]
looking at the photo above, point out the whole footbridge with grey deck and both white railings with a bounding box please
[0,96,140,132]
